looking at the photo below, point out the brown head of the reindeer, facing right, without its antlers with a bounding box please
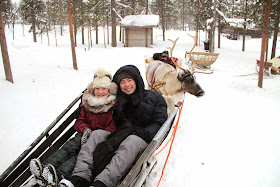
[177,69,205,97]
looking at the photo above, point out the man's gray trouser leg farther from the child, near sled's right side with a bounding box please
[95,135,148,187]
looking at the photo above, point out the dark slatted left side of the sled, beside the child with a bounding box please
[0,92,83,187]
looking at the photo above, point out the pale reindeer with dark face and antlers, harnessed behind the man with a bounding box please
[146,34,204,114]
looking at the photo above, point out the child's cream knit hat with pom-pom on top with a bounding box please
[92,68,112,89]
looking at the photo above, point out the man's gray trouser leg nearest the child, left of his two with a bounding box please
[72,129,111,182]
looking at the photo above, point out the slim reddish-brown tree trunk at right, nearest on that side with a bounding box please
[258,0,271,88]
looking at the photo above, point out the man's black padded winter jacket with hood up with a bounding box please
[113,65,168,143]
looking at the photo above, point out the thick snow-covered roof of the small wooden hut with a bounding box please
[121,15,159,27]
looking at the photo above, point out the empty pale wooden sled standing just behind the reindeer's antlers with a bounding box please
[185,51,219,69]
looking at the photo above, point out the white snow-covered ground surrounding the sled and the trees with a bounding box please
[0,25,280,187]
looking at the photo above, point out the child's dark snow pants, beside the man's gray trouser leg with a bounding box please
[43,133,82,180]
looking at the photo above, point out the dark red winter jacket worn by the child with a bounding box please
[74,104,116,133]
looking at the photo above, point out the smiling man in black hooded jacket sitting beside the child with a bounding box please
[93,65,168,187]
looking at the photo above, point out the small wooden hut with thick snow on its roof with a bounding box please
[121,15,159,47]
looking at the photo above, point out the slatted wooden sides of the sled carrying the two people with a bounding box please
[0,92,181,187]
